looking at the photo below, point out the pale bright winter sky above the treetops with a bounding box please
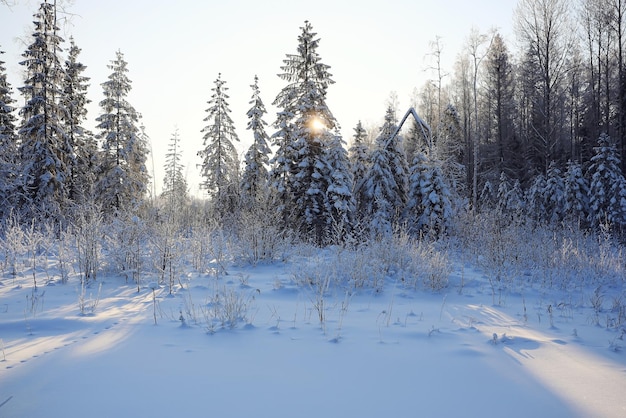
[0,0,517,195]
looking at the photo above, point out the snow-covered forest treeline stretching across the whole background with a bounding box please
[0,0,626,245]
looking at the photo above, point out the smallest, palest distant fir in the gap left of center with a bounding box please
[161,128,189,215]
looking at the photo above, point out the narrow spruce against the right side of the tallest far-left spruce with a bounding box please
[61,38,98,205]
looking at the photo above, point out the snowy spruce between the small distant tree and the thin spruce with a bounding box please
[198,73,239,216]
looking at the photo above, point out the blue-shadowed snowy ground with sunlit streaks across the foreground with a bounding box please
[0,248,626,418]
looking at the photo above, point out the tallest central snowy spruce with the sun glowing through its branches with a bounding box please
[272,21,349,245]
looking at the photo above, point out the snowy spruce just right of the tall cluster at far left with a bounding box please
[96,51,149,214]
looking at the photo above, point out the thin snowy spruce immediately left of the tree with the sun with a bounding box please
[241,76,271,209]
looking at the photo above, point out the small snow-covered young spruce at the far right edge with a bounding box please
[588,134,626,226]
